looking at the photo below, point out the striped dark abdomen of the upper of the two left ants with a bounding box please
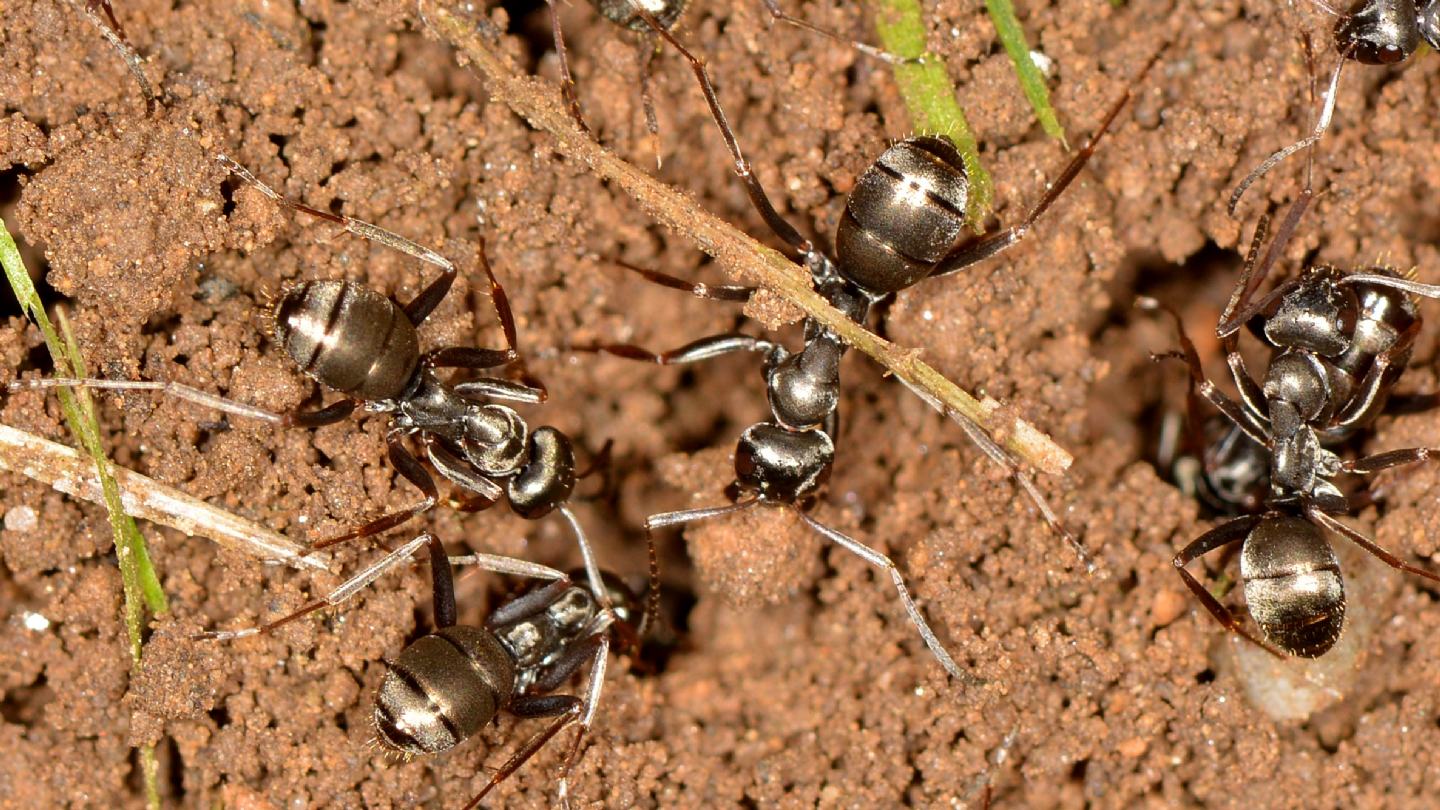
[275,281,420,401]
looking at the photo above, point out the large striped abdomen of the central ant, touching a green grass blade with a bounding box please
[835,135,971,297]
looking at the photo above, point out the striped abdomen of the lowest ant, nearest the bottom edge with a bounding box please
[374,624,516,754]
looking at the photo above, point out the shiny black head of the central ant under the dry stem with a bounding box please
[734,422,835,503]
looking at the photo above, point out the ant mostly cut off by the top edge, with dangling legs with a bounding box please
[546,0,917,164]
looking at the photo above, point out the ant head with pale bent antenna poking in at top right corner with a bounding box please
[1228,0,1440,216]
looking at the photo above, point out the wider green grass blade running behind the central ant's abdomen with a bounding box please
[870,0,995,223]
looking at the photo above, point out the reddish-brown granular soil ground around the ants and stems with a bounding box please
[0,0,1440,809]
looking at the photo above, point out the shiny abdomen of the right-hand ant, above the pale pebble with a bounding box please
[1240,515,1345,659]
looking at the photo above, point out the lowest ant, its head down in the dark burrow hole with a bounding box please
[197,533,660,810]
